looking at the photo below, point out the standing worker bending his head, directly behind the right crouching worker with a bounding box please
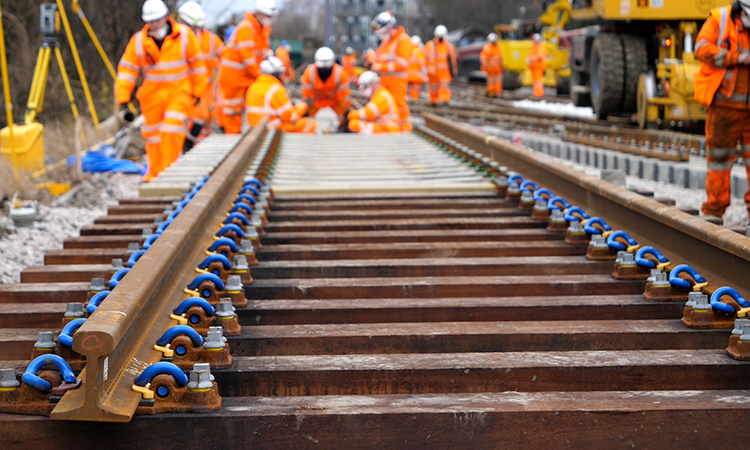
[370,11,414,131]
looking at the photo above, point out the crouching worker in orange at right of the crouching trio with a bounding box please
[347,71,401,134]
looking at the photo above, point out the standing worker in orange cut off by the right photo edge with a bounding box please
[695,0,750,224]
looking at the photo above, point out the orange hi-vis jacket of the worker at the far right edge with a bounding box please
[694,5,750,109]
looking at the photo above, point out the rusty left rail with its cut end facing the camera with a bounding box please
[50,120,266,422]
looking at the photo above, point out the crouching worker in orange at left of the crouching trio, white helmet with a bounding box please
[245,56,317,133]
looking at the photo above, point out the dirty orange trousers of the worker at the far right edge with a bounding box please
[702,106,750,217]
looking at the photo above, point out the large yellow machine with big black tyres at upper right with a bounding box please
[562,0,732,127]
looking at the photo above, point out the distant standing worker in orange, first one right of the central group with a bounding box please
[425,25,458,106]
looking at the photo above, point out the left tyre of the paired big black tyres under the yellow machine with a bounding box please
[589,33,625,120]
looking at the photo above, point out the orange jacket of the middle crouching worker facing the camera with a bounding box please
[300,63,351,113]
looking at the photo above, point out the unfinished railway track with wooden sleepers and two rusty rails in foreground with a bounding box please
[0,114,750,448]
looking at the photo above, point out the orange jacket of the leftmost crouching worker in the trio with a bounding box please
[245,73,315,132]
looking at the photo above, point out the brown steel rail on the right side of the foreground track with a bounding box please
[424,114,750,292]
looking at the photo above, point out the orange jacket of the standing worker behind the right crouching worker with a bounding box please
[370,27,414,89]
